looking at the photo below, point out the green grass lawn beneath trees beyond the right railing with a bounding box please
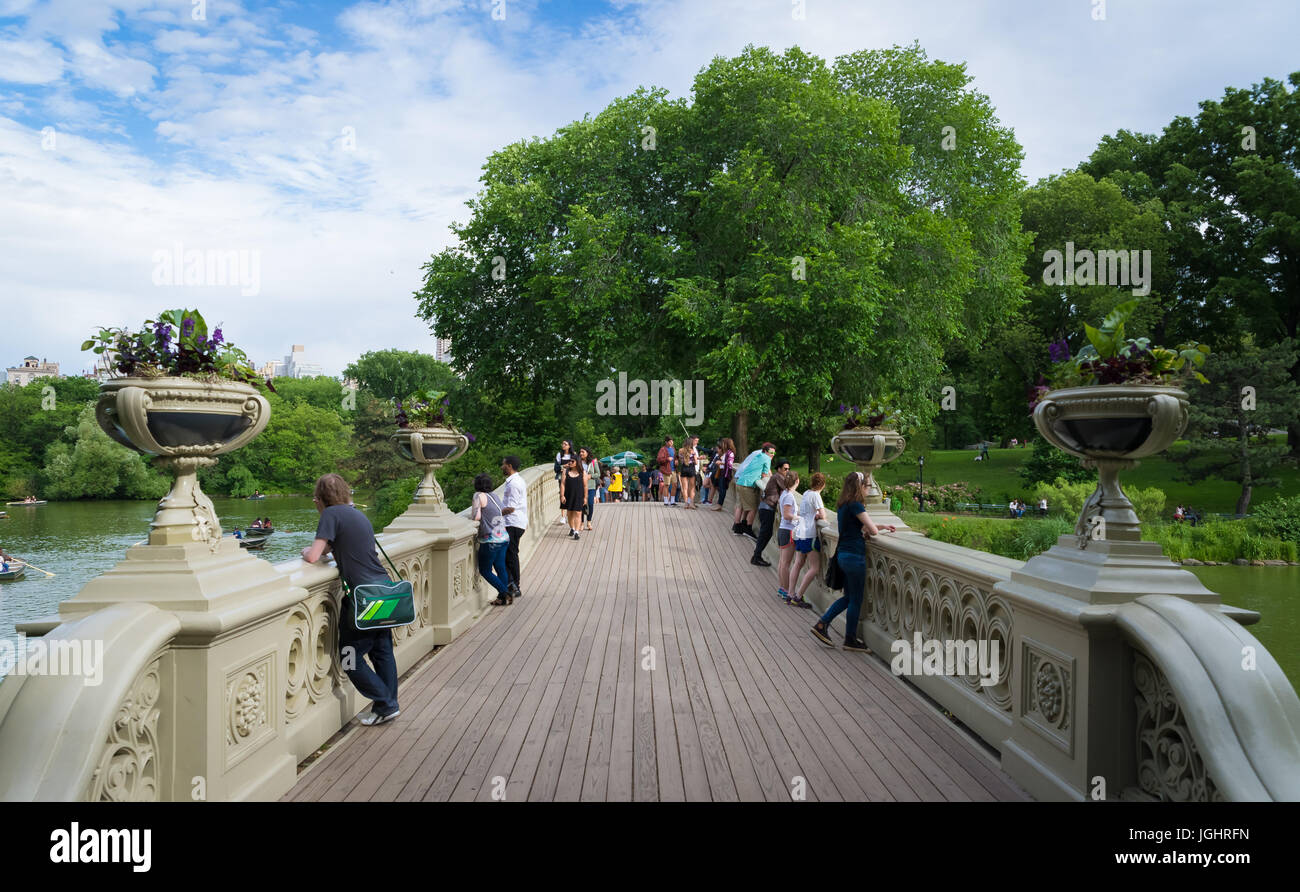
[790,443,1300,515]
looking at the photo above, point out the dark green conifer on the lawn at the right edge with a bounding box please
[1170,339,1300,514]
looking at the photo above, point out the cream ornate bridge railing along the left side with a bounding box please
[0,466,555,801]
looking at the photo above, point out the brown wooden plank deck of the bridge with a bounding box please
[285,503,1027,801]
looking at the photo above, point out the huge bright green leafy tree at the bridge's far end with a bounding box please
[416,41,1024,460]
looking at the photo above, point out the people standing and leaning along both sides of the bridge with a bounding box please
[303,437,894,726]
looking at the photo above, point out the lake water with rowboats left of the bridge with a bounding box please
[0,497,374,676]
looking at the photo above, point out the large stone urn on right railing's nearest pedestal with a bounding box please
[1034,384,1187,547]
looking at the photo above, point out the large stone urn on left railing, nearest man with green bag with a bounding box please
[95,377,270,547]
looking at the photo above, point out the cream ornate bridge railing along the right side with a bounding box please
[766,508,1300,801]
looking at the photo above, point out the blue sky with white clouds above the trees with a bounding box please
[0,0,1300,373]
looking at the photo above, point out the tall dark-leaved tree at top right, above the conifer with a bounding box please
[1083,72,1300,455]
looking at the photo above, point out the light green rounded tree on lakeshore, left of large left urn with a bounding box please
[42,404,169,499]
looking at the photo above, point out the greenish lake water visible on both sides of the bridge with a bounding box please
[0,497,1300,689]
